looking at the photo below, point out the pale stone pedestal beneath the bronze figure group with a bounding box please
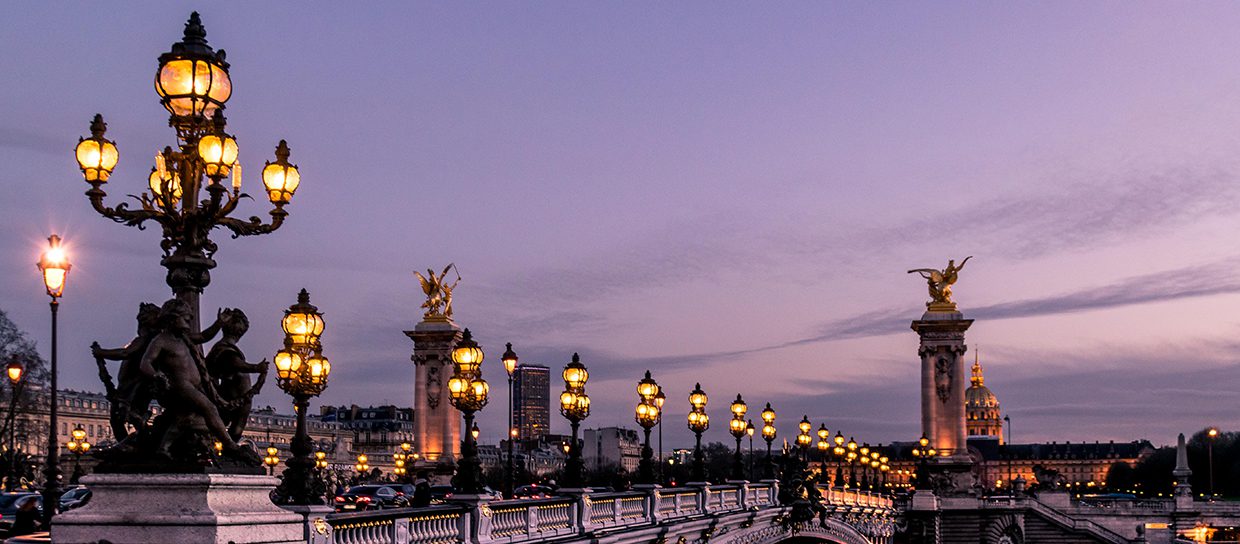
[52,473,306,544]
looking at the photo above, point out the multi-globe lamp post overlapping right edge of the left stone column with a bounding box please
[448,328,491,496]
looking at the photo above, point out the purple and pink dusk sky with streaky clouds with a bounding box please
[0,1,1240,447]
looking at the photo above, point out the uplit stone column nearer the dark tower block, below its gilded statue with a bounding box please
[404,316,461,473]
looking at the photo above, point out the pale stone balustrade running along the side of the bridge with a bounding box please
[325,482,892,544]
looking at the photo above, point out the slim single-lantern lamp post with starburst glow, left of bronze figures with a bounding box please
[37,234,71,527]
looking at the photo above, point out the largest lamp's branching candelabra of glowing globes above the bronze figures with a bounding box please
[74,12,301,331]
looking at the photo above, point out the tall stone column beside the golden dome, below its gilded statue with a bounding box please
[913,305,973,458]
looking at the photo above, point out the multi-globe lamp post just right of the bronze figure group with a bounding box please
[275,289,331,506]
